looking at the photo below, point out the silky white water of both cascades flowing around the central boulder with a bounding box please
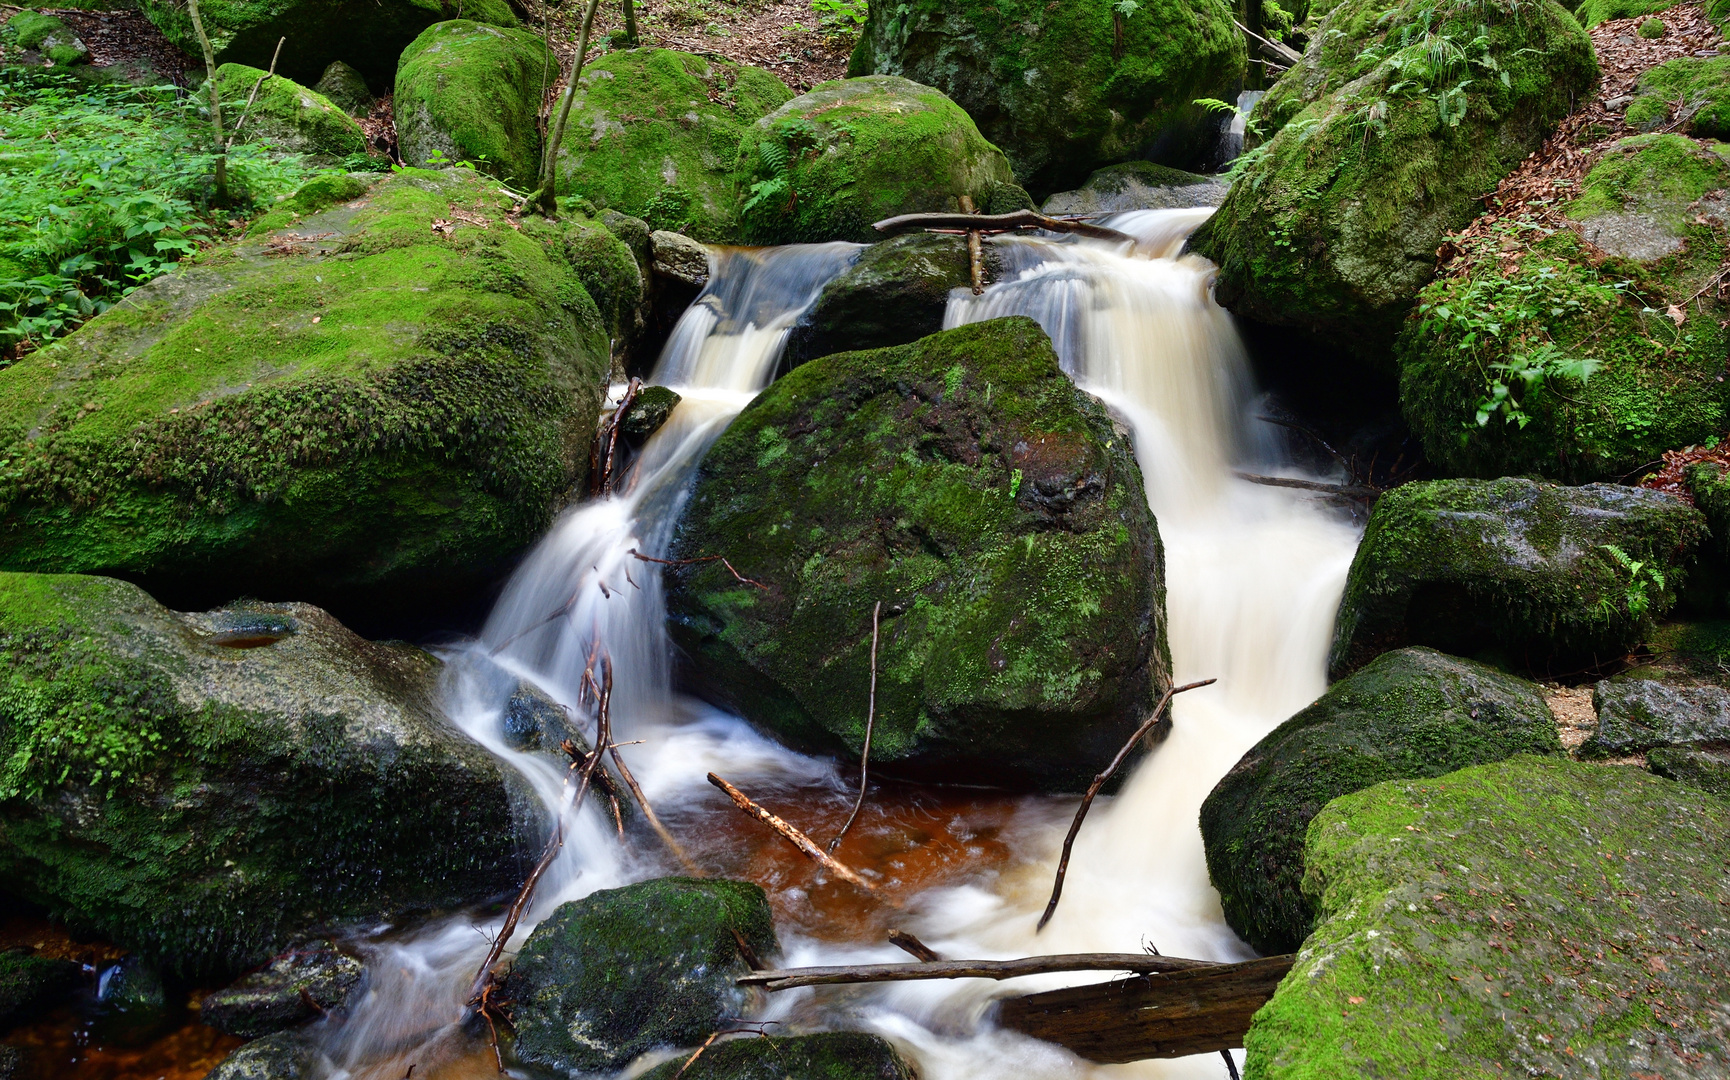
[314,209,1356,1080]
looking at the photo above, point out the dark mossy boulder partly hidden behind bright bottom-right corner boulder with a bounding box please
[1201,649,1562,954]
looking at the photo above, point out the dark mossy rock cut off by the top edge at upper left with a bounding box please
[138,0,519,93]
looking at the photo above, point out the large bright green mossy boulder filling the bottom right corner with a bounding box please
[1244,756,1730,1080]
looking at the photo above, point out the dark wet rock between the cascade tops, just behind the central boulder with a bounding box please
[784,232,1003,367]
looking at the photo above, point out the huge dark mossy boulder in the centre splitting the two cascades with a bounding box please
[666,317,1171,791]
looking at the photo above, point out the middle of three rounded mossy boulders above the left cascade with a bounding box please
[559,48,792,242]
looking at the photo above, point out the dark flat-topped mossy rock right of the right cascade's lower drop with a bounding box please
[1329,478,1706,677]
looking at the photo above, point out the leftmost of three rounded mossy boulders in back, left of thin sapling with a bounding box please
[391,19,559,187]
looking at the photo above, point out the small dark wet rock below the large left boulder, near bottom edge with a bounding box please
[199,940,365,1038]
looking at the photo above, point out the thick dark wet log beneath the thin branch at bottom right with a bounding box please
[996,955,1296,1064]
